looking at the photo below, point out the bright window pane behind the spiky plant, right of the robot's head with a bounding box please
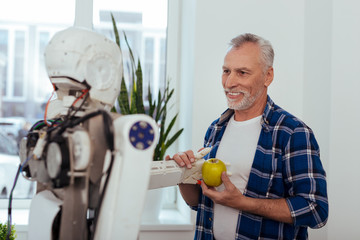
[93,0,177,208]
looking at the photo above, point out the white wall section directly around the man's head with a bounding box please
[188,0,304,148]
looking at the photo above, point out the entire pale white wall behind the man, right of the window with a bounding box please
[170,0,360,239]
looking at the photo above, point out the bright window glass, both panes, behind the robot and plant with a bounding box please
[0,0,176,206]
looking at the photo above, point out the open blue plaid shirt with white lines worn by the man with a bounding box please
[192,97,328,240]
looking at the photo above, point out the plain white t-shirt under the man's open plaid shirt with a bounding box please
[213,115,261,240]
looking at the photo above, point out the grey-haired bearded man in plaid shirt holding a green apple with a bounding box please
[168,34,328,240]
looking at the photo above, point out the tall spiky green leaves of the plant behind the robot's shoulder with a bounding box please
[111,14,184,161]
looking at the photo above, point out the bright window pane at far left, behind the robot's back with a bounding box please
[0,0,75,199]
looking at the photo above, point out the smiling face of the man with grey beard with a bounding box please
[222,43,272,110]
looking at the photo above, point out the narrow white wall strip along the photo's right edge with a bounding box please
[328,0,360,240]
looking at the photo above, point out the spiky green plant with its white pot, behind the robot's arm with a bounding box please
[111,14,184,219]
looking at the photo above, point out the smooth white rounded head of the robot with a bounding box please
[45,27,122,108]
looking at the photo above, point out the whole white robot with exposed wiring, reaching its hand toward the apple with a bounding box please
[20,27,209,240]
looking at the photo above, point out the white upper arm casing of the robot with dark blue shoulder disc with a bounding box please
[94,114,158,240]
